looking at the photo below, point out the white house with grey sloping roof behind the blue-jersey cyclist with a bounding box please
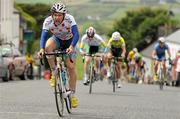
[141,29,180,76]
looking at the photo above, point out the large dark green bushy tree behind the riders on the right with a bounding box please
[108,7,178,50]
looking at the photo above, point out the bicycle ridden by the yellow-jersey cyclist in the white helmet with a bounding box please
[110,56,123,92]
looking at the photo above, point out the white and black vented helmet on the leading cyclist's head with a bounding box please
[50,2,67,13]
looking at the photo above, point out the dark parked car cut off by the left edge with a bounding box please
[0,51,9,81]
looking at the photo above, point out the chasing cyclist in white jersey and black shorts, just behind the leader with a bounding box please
[79,26,106,85]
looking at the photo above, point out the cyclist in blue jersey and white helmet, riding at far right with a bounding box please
[152,37,171,79]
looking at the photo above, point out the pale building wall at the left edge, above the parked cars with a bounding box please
[0,0,20,48]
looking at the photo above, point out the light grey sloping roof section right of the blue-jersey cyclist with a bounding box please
[166,29,180,44]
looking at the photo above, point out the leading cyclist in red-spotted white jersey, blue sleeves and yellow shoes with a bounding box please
[38,2,79,108]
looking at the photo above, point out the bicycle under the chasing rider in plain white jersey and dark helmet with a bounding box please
[83,54,102,94]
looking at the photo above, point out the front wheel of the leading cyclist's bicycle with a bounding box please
[54,73,64,117]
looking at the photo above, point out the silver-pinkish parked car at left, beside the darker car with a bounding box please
[0,45,27,80]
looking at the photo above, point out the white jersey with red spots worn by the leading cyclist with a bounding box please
[43,14,76,40]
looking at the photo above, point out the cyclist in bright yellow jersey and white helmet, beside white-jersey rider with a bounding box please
[106,31,126,88]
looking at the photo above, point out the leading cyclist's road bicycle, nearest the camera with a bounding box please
[41,50,72,117]
